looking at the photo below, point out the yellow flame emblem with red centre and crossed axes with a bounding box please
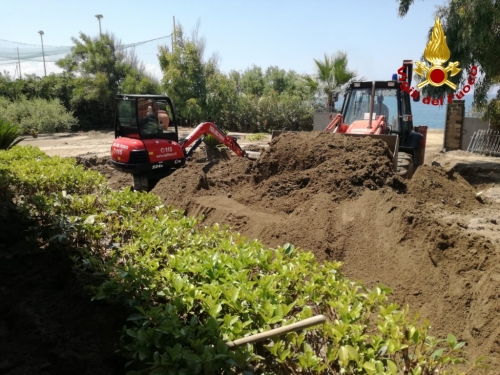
[415,18,462,90]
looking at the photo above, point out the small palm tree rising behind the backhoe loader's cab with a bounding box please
[304,51,358,109]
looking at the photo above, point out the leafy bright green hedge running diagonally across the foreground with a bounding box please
[0,146,480,375]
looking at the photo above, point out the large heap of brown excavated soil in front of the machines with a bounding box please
[153,133,500,368]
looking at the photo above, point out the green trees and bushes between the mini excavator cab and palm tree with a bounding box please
[159,25,312,132]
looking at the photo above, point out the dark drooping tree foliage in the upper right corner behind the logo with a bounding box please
[399,0,500,108]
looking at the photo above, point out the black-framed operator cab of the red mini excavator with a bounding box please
[115,95,179,142]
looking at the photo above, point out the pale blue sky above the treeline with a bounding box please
[0,0,445,80]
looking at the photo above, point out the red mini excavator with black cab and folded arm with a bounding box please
[111,95,247,191]
